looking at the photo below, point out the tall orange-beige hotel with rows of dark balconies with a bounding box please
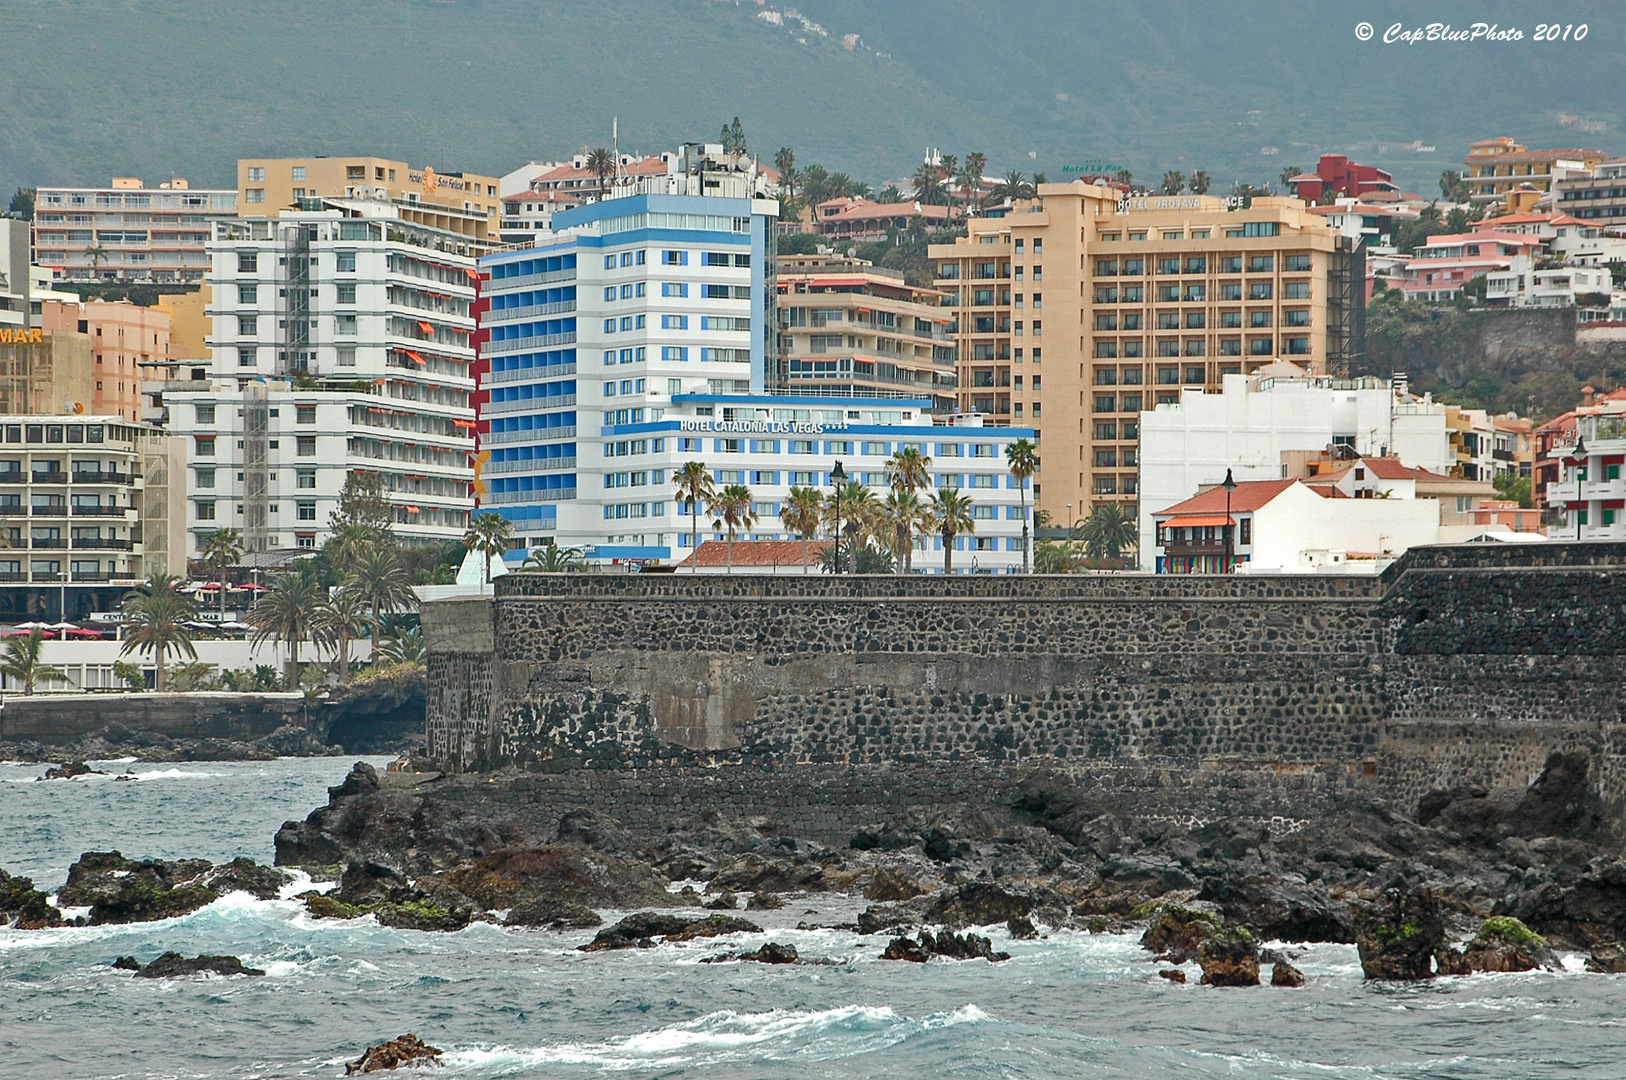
[930,182,1364,520]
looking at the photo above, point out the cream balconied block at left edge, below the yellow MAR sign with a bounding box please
[0,416,185,618]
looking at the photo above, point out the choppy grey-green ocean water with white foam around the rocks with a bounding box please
[0,758,1626,1080]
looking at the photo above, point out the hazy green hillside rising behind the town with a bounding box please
[0,0,1626,192]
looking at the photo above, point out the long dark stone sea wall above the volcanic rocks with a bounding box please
[424,543,1626,836]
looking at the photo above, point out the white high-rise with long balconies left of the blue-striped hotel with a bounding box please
[164,200,478,553]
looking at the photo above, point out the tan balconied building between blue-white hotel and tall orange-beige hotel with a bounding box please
[771,254,956,412]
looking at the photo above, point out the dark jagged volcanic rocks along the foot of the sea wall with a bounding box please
[0,755,1626,987]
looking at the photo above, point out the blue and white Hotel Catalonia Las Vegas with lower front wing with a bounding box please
[476,146,1034,571]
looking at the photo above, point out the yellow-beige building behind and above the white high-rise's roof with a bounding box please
[237,156,502,246]
